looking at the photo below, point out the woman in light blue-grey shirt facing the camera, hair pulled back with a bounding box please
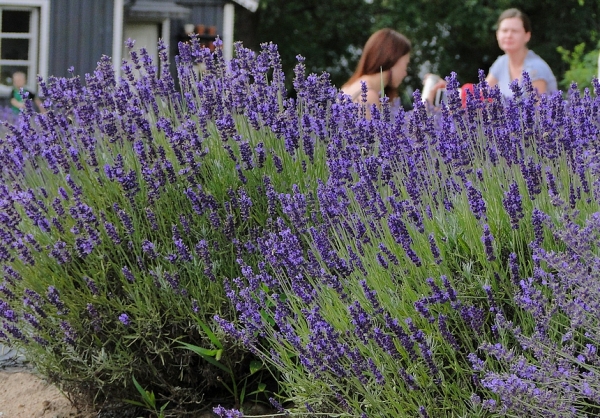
[486,9,558,97]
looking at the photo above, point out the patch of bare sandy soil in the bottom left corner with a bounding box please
[0,370,93,418]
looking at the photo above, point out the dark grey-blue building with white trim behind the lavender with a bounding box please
[0,0,258,95]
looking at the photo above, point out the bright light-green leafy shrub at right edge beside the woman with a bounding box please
[556,42,600,91]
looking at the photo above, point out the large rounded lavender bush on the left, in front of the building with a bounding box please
[0,39,334,413]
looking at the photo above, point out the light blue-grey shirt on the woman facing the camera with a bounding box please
[490,50,558,97]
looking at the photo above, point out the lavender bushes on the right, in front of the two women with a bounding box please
[219,73,600,417]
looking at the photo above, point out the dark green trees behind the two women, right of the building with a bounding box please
[238,0,600,100]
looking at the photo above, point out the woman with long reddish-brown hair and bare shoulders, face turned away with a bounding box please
[341,28,411,109]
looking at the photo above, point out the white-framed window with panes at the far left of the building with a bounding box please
[0,5,40,86]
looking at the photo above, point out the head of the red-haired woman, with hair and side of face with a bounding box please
[346,29,411,98]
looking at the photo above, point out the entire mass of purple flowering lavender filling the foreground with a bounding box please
[0,40,600,417]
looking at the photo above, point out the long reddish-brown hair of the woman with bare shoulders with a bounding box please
[344,29,411,99]
